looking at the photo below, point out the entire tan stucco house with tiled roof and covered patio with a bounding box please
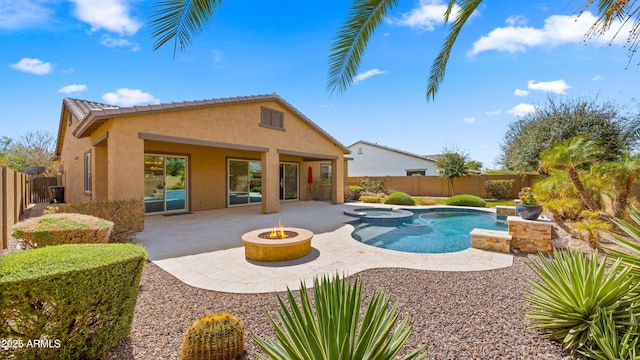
[55,94,349,214]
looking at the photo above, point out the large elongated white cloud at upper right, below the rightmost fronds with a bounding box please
[468,11,626,56]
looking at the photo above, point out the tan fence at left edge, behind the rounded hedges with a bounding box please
[0,166,31,249]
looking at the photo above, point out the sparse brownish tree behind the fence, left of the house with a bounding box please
[1,131,57,176]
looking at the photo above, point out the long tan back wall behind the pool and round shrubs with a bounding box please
[348,175,539,199]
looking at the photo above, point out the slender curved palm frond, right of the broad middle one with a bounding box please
[426,0,482,101]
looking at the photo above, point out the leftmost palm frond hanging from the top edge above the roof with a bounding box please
[151,0,222,57]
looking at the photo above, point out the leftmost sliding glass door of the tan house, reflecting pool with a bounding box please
[144,154,187,214]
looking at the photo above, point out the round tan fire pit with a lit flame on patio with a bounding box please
[242,228,313,262]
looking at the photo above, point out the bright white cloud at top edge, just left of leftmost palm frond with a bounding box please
[71,0,142,35]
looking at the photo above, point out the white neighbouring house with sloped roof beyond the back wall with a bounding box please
[348,140,439,176]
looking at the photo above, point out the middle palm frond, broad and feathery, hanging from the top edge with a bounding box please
[327,0,398,94]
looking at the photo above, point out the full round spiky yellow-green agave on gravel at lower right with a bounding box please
[525,250,640,350]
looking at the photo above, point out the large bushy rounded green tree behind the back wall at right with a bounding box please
[499,97,636,172]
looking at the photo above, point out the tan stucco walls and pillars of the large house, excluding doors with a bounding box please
[61,101,344,212]
